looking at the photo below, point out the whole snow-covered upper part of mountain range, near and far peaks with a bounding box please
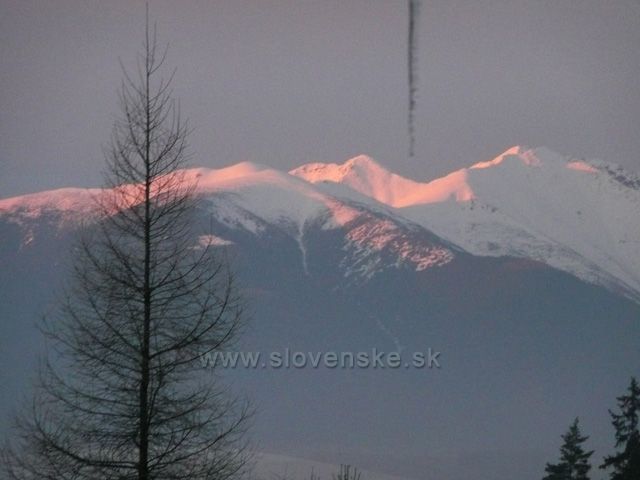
[0,146,640,301]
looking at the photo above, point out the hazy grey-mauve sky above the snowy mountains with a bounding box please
[0,0,640,197]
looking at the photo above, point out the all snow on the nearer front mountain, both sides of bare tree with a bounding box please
[0,162,453,278]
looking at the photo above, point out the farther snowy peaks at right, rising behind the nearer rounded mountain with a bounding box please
[291,147,640,299]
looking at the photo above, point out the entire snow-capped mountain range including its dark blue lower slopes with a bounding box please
[0,148,640,480]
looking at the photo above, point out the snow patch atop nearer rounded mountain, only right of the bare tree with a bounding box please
[188,163,453,278]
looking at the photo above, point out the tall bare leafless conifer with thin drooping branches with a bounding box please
[3,9,248,480]
